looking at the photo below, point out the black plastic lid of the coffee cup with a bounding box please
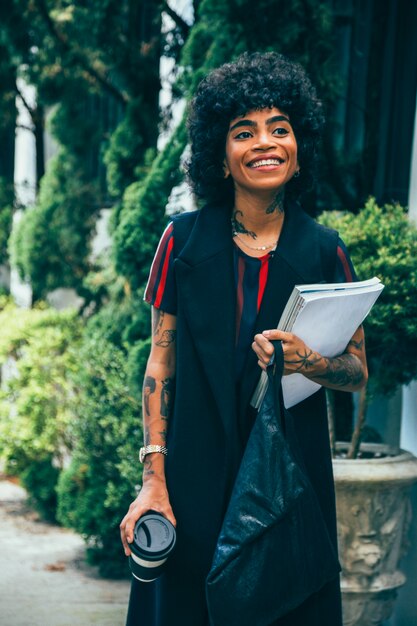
[130,511,176,561]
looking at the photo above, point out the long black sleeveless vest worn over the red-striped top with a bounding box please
[129,203,341,626]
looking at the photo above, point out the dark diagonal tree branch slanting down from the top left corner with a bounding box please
[34,0,129,105]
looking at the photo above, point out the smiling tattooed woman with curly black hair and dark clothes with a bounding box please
[121,53,367,626]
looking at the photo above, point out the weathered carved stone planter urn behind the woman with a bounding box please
[333,444,417,626]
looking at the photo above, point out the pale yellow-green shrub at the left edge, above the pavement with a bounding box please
[0,303,80,519]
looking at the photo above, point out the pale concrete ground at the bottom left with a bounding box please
[0,480,129,626]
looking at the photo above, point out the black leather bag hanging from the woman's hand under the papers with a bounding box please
[206,344,340,626]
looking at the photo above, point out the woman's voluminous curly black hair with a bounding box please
[187,52,324,203]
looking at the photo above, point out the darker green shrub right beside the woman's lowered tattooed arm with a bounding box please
[58,326,143,577]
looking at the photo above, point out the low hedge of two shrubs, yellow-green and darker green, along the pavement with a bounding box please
[0,296,149,577]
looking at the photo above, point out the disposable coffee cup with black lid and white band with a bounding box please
[129,511,176,582]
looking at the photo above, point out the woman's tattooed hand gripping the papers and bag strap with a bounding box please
[252,329,326,376]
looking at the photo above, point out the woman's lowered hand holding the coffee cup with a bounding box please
[120,476,177,556]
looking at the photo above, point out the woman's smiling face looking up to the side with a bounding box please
[224,107,299,194]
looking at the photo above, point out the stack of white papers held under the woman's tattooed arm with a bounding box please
[251,278,384,408]
